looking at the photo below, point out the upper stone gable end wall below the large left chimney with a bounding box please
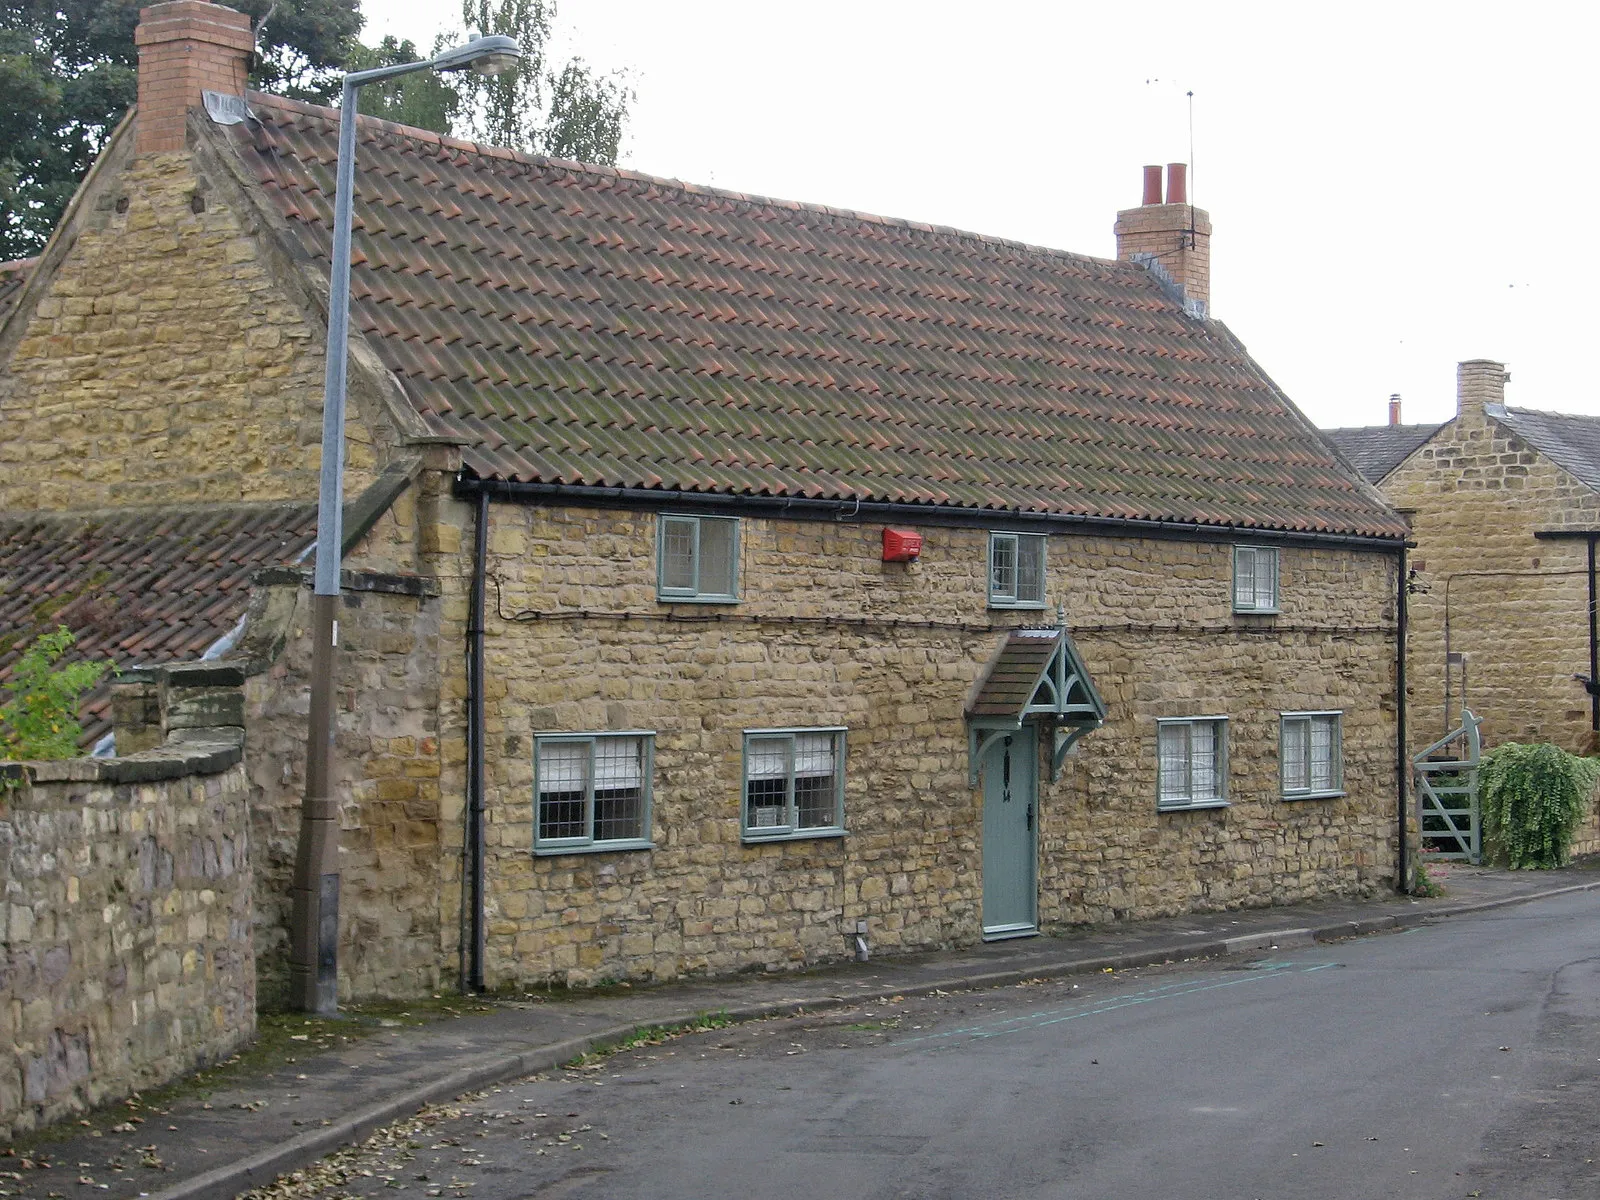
[0,138,379,510]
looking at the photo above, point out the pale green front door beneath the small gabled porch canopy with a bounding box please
[984,726,1038,941]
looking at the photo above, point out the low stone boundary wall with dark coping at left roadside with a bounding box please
[0,736,256,1138]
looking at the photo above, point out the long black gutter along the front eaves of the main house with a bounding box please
[454,474,1406,554]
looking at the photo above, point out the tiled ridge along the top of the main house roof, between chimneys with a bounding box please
[246,91,1154,282]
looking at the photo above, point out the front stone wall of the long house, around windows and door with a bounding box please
[444,504,1397,986]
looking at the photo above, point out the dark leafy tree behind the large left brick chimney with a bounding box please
[0,0,362,261]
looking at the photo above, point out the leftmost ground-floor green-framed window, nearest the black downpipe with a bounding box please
[533,730,656,854]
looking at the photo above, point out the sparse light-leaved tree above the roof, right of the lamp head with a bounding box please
[458,0,634,165]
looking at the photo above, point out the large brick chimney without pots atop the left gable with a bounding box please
[133,0,256,154]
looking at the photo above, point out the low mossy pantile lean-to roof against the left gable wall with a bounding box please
[0,504,317,746]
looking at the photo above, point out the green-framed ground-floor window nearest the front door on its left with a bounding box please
[739,726,846,842]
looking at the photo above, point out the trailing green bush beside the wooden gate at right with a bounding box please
[1478,742,1600,869]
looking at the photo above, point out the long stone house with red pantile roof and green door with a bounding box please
[0,0,1406,998]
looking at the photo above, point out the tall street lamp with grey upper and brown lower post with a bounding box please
[290,35,522,1016]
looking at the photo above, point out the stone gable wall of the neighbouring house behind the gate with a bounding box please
[1382,406,1600,754]
